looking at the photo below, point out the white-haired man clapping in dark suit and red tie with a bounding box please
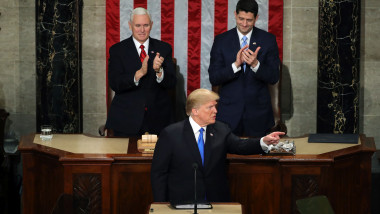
[106,7,176,136]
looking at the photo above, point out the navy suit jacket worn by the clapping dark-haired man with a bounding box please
[208,27,280,136]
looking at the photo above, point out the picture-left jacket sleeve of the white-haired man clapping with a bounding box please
[108,44,136,93]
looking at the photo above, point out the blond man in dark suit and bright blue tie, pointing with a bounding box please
[151,89,285,203]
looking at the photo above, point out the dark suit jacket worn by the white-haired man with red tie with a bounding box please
[106,37,176,135]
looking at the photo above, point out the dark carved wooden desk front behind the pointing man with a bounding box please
[19,134,375,214]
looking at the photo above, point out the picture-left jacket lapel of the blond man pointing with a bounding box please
[183,119,203,169]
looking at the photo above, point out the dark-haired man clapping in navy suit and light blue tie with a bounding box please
[208,0,280,136]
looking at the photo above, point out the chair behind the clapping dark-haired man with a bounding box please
[212,68,288,133]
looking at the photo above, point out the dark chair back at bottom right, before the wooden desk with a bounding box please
[296,195,334,214]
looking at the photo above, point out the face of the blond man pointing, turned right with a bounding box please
[193,100,218,126]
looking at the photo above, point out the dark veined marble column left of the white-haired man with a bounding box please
[36,0,83,133]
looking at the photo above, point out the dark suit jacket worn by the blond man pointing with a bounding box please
[151,118,263,202]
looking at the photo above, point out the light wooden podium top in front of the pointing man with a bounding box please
[147,203,242,214]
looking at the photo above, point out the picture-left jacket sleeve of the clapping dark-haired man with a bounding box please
[208,36,237,86]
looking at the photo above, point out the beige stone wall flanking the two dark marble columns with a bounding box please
[0,0,380,153]
